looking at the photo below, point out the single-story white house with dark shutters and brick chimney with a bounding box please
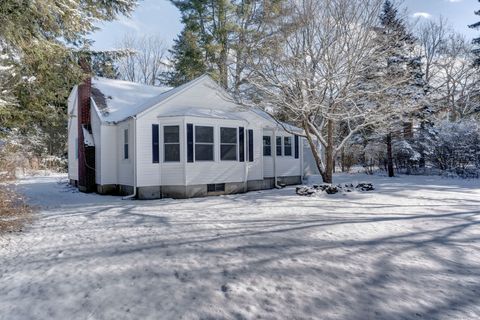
[68,75,304,199]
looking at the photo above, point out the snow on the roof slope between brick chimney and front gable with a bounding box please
[92,77,172,122]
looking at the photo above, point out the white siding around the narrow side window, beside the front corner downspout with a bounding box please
[116,119,132,186]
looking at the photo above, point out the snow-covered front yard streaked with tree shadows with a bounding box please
[0,175,480,319]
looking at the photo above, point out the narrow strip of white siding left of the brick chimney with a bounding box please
[68,86,78,180]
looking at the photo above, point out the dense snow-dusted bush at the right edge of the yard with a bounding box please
[430,120,480,177]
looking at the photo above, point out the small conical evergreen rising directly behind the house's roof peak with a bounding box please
[164,29,208,87]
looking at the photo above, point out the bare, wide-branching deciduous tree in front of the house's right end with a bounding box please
[242,0,414,183]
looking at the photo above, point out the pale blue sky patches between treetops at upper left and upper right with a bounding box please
[91,0,480,50]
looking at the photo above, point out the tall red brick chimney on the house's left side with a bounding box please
[78,58,96,192]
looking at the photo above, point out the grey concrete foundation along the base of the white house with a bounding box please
[93,176,302,200]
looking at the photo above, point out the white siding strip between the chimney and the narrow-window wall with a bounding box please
[97,124,117,185]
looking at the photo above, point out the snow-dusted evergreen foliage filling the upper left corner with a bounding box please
[0,0,136,159]
